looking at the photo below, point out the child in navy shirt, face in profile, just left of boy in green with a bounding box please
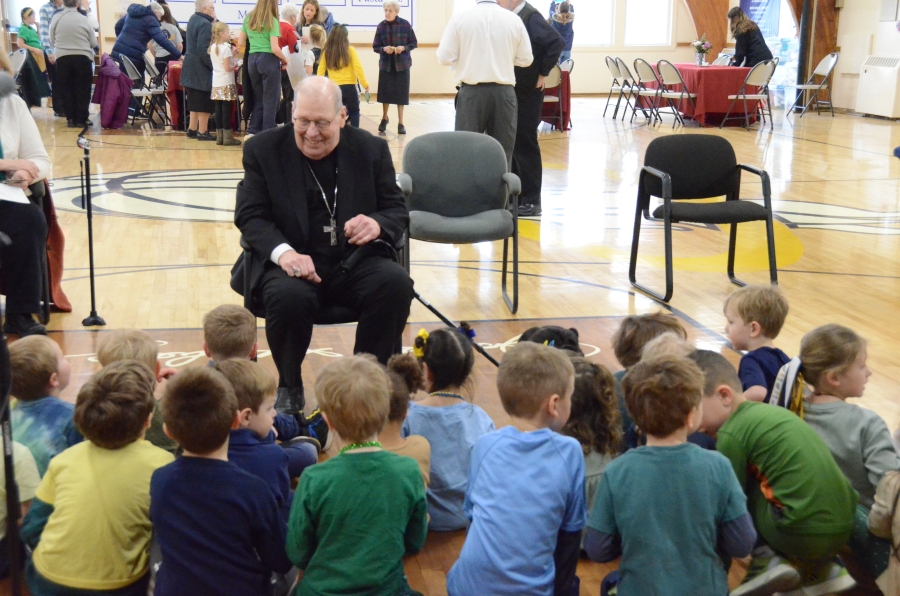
[216,360,318,523]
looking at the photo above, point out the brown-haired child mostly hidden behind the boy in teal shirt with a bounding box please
[611,311,687,451]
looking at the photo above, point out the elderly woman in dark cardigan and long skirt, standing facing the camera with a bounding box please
[372,0,418,135]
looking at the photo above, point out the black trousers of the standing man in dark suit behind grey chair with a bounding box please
[512,88,544,205]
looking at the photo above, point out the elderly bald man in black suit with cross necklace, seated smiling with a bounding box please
[234,77,413,413]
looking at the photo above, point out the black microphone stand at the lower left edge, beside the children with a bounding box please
[0,233,22,596]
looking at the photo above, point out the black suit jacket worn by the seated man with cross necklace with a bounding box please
[234,125,409,290]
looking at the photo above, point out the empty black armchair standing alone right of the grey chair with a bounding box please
[628,135,778,302]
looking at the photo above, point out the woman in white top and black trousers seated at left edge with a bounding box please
[0,52,53,337]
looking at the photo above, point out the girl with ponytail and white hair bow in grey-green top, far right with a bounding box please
[773,325,900,576]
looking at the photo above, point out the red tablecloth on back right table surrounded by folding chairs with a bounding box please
[675,64,756,126]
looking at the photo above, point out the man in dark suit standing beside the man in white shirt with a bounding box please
[501,0,565,217]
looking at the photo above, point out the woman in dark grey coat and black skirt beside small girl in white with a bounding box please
[181,0,221,141]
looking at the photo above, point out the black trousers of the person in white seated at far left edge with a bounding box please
[0,201,47,314]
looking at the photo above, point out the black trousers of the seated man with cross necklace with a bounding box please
[262,257,413,387]
